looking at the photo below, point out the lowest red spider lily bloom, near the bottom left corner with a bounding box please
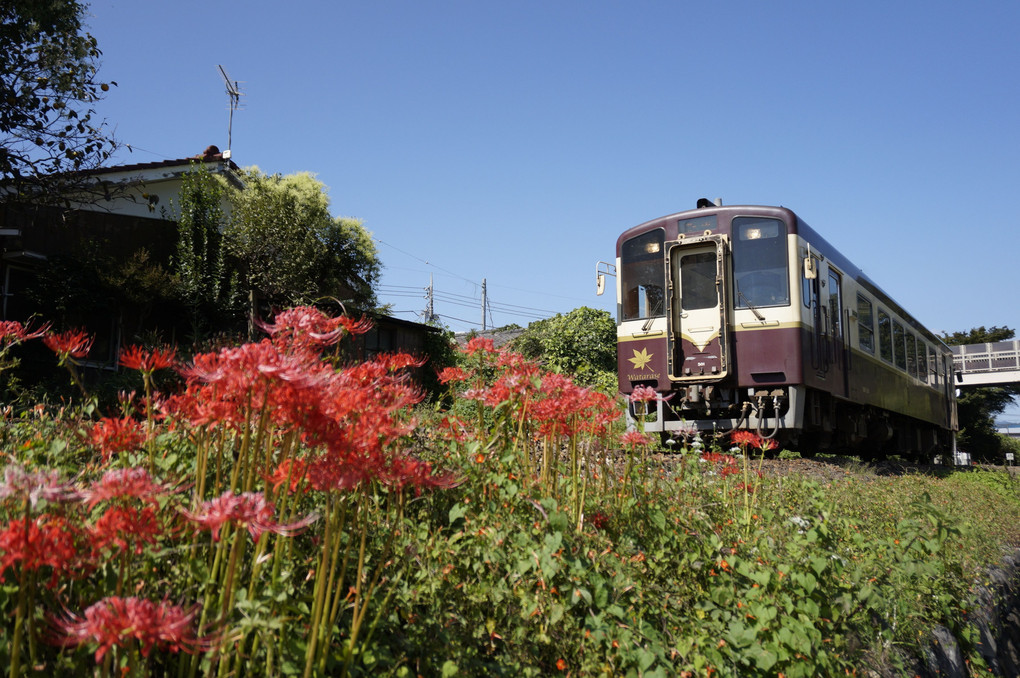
[50,595,211,664]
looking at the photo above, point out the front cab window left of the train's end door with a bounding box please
[620,228,666,320]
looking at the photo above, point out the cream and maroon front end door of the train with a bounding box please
[667,236,729,382]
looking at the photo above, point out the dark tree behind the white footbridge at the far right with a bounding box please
[942,326,1020,461]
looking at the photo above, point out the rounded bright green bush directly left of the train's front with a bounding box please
[511,306,617,390]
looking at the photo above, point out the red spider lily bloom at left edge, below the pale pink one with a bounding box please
[0,515,79,586]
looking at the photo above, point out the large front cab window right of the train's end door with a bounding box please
[731,216,789,308]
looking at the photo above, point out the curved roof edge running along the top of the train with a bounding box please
[616,205,946,347]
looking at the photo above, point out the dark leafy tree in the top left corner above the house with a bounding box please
[0,0,116,202]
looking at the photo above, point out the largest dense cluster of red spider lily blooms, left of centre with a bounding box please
[169,330,446,490]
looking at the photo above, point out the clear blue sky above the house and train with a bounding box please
[88,0,1020,411]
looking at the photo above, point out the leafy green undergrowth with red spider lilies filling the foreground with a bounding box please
[0,314,1020,677]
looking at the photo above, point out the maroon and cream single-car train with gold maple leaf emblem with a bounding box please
[599,199,958,454]
